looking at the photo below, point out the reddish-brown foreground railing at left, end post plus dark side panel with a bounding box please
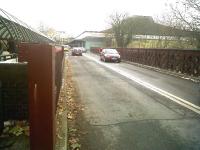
[0,43,64,150]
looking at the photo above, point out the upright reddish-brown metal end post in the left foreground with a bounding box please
[19,43,56,150]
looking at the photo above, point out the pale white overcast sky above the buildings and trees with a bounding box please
[0,0,173,36]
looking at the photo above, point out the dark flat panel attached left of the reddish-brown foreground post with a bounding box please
[0,63,29,134]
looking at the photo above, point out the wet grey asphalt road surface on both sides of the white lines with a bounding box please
[69,53,200,150]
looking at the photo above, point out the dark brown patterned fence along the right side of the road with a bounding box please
[91,48,200,76]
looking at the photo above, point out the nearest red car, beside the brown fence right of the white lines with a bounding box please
[100,49,121,63]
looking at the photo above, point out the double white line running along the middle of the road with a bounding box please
[84,54,200,114]
